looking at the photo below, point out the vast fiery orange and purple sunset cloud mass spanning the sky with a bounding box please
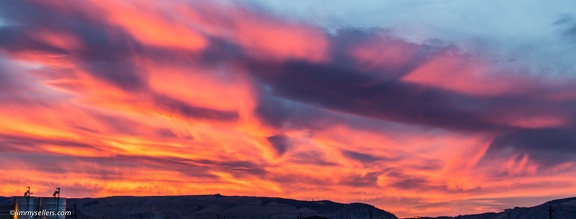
[0,1,576,216]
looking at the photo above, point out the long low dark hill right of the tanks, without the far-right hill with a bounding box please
[67,195,397,219]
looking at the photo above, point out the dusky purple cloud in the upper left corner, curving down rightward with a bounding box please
[0,1,146,91]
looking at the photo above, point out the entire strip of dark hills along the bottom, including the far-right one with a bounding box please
[0,195,576,219]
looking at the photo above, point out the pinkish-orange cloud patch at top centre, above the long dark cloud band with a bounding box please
[176,4,328,61]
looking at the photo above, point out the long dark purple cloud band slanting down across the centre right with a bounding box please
[251,57,494,130]
